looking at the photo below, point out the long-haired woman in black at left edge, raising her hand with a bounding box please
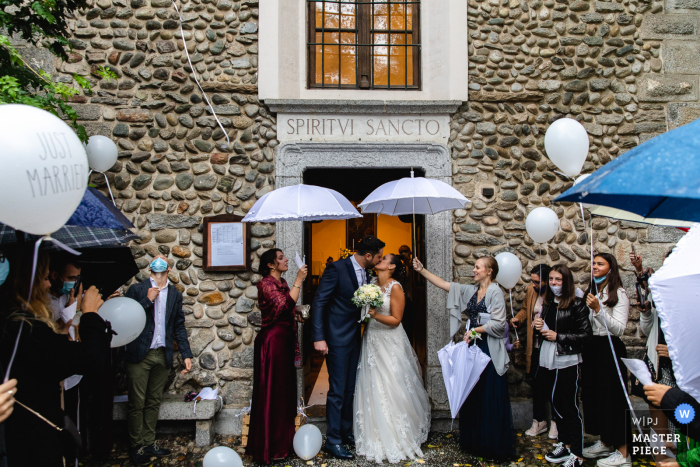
[0,247,111,467]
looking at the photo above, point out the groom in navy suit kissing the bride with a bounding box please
[311,236,384,459]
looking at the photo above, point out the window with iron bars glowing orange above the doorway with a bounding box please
[307,0,421,90]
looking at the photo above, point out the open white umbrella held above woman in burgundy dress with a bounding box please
[243,184,362,222]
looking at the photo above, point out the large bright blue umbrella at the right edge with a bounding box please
[555,120,700,222]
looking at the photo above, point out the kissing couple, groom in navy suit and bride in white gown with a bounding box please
[311,236,430,463]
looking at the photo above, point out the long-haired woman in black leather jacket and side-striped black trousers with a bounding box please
[534,264,593,467]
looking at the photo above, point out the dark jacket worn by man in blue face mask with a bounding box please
[124,279,192,368]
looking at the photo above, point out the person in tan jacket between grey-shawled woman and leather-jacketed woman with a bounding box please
[510,264,558,439]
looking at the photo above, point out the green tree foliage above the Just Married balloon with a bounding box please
[0,0,117,142]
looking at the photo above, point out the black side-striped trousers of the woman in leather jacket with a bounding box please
[540,365,583,457]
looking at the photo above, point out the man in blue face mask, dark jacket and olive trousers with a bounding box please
[123,255,192,465]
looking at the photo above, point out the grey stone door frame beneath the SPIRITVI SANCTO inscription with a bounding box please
[275,141,453,406]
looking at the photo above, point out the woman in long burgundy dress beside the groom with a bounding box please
[246,248,307,464]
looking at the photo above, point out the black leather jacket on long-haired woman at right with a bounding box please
[535,297,593,355]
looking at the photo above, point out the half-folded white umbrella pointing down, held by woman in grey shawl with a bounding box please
[438,336,491,419]
